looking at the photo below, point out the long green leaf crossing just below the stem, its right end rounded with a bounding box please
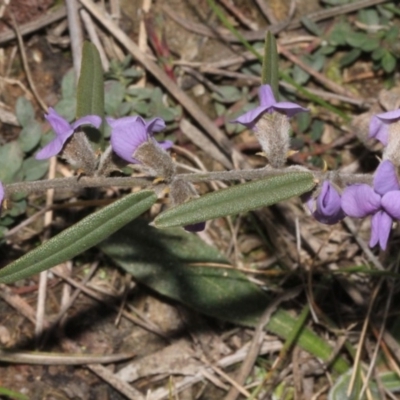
[154,172,315,228]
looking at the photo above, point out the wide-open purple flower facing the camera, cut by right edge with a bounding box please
[342,160,400,250]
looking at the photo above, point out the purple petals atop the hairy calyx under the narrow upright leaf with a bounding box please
[232,85,308,129]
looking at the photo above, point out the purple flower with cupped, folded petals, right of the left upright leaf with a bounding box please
[106,116,173,164]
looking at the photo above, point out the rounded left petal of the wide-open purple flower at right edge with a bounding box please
[342,184,381,218]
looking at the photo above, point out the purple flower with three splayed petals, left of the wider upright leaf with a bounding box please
[36,107,101,160]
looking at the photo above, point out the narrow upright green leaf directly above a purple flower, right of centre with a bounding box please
[261,32,279,101]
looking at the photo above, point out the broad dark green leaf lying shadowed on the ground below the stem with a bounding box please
[98,219,349,373]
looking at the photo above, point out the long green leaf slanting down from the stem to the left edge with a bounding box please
[0,191,157,283]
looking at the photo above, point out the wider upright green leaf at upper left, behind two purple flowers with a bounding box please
[76,42,104,140]
